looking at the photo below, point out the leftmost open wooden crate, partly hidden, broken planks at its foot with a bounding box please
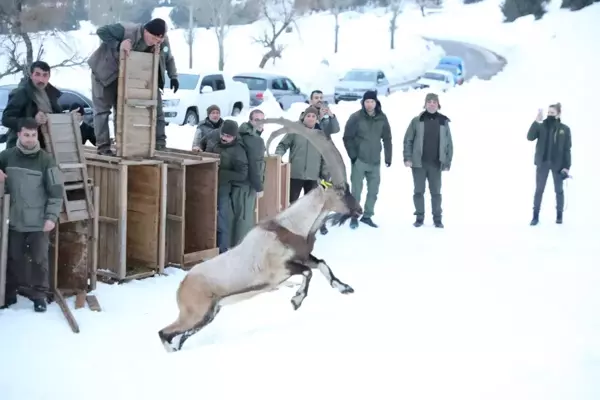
[49,187,101,333]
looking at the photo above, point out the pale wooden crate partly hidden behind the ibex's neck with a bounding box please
[256,155,291,222]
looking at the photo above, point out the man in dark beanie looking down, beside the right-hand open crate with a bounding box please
[200,120,248,253]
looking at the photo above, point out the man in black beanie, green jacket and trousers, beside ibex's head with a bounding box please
[344,90,392,229]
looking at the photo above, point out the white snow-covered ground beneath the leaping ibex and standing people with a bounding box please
[0,0,600,400]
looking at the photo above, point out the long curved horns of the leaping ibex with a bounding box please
[261,118,347,185]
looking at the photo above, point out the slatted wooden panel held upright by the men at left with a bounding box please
[42,113,94,222]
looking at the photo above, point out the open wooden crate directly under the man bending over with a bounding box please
[86,149,167,281]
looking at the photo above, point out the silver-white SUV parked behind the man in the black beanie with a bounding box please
[334,69,391,104]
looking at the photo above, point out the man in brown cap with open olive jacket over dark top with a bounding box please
[404,93,454,228]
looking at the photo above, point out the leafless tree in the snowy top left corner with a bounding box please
[0,0,86,79]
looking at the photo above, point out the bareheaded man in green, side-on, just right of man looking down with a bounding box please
[231,109,266,246]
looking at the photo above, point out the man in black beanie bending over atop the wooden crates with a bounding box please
[88,18,179,155]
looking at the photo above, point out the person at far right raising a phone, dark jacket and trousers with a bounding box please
[527,103,571,225]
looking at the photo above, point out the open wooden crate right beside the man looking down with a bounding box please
[154,149,219,268]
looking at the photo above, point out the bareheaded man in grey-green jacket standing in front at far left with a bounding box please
[0,118,63,312]
